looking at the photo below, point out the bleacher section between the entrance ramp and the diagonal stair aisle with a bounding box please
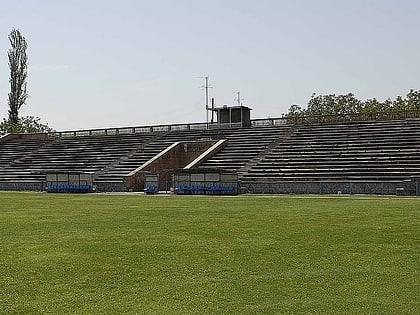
[200,125,290,171]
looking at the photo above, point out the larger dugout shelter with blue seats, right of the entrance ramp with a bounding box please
[173,169,239,195]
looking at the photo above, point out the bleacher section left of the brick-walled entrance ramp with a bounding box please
[0,126,231,190]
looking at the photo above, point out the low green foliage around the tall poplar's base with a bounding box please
[0,116,53,134]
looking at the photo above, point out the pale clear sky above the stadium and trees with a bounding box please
[0,0,420,130]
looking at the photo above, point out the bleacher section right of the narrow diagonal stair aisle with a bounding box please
[243,120,420,181]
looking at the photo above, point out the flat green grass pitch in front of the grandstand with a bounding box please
[0,192,420,314]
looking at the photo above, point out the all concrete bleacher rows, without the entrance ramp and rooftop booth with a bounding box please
[0,119,420,192]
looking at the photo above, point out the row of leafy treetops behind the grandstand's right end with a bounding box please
[285,89,420,123]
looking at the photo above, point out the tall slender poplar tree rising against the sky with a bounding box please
[7,29,28,125]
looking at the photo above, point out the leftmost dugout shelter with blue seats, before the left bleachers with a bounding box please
[46,172,96,193]
